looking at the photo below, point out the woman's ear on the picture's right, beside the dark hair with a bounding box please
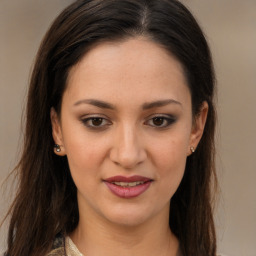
[188,101,209,155]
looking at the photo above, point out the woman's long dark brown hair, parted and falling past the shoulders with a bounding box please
[3,0,216,256]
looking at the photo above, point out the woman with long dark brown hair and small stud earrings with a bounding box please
[3,0,216,256]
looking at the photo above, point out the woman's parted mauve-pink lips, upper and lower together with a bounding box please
[104,175,153,198]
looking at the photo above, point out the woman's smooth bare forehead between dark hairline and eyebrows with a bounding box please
[65,38,189,106]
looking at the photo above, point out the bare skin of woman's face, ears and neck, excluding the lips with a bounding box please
[51,38,208,256]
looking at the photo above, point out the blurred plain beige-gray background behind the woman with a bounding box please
[0,0,256,256]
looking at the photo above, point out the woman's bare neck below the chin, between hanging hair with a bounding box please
[70,202,179,256]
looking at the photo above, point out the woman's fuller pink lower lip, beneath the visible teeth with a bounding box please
[105,181,152,198]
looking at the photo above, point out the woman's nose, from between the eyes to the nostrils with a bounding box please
[110,124,147,169]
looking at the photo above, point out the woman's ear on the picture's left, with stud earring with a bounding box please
[50,108,66,156]
